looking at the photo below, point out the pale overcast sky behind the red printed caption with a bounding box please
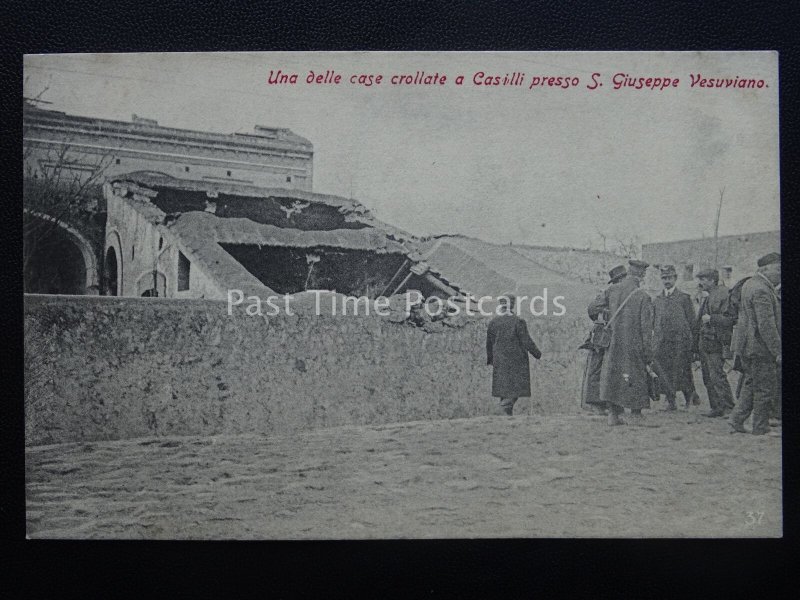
[24,52,779,248]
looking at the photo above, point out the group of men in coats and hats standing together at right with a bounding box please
[582,253,781,435]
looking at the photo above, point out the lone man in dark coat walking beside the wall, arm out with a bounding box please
[486,296,542,415]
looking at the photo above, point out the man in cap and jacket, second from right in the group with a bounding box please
[695,269,734,417]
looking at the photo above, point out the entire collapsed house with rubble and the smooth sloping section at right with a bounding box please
[103,171,592,331]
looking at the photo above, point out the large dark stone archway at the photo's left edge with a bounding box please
[23,209,100,295]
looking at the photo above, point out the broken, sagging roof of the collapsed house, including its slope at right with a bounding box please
[109,172,594,304]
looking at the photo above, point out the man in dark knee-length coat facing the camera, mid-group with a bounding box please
[653,265,700,410]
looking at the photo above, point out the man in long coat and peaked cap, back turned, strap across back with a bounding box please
[600,260,653,426]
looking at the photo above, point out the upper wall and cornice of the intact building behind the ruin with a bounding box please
[23,104,314,191]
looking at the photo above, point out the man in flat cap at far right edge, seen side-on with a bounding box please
[730,252,781,435]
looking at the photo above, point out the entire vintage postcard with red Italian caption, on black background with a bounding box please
[22,52,783,540]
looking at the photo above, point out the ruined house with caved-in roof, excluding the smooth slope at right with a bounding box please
[104,172,460,299]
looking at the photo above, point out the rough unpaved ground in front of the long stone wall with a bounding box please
[26,409,782,539]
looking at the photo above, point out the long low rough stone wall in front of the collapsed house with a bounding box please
[25,296,586,445]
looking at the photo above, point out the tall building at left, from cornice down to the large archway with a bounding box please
[23,102,314,294]
